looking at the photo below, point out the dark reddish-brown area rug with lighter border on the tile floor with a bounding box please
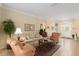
[35,42,60,56]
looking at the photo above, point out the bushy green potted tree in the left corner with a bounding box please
[2,19,15,37]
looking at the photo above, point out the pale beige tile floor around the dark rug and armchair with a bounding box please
[0,38,79,56]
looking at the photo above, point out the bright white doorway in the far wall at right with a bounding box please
[61,21,72,38]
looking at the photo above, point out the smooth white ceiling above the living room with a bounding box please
[3,3,79,19]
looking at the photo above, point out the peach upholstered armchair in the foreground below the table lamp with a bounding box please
[7,39,36,56]
